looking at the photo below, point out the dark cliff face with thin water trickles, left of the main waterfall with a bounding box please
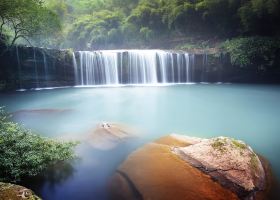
[0,46,74,90]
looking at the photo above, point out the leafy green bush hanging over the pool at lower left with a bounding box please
[0,108,77,182]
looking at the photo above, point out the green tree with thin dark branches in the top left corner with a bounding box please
[0,0,61,46]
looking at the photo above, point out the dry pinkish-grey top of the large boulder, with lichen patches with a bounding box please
[173,137,265,197]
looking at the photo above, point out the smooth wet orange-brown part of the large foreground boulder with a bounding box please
[111,136,238,200]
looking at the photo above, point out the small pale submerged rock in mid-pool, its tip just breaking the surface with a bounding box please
[88,122,135,150]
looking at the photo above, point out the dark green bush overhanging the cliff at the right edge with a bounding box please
[223,37,280,70]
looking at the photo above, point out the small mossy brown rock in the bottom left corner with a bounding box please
[0,182,41,200]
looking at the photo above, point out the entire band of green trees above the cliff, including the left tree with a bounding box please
[0,0,280,49]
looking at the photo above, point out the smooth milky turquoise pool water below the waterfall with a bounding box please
[0,84,280,200]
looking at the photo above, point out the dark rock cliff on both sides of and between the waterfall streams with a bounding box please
[0,46,280,90]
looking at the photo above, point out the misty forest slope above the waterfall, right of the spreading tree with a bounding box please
[41,0,280,49]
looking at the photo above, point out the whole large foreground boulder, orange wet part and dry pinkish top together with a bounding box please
[110,134,272,200]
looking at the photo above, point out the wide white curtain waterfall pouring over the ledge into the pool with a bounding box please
[73,50,194,85]
